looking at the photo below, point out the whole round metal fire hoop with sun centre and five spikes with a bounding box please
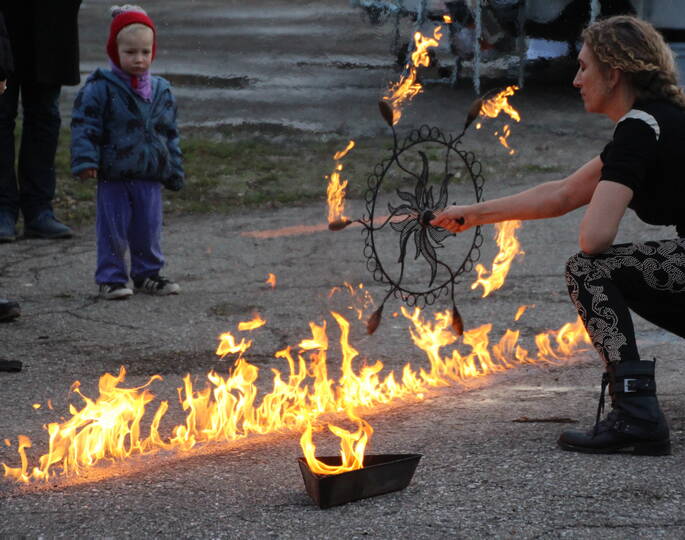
[329,96,484,335]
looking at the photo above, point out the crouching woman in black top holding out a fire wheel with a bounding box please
[432,16,685,455]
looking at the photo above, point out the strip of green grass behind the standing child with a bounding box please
[54,128,388,224]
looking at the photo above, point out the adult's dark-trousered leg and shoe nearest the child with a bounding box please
[17,82,72,238]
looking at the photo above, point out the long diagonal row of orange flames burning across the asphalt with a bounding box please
[3,307,590,483]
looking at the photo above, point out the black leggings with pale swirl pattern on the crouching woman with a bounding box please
[566,238,685,363]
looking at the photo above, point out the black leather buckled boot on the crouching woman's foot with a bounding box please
[559,361,671,456]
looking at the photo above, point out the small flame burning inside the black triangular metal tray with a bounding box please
[300,409,373,474]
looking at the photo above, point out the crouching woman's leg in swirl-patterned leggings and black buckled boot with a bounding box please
[559,240,685,455]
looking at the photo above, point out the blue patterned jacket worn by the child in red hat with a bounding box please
[71,69,184,191]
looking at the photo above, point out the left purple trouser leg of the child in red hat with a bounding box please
[95,180,131,285]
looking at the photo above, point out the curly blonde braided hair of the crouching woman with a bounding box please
[581,15,685,109]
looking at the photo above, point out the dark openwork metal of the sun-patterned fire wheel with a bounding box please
[329,100,484,335]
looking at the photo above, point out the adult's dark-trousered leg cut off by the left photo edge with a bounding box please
[0,77,19,242]
